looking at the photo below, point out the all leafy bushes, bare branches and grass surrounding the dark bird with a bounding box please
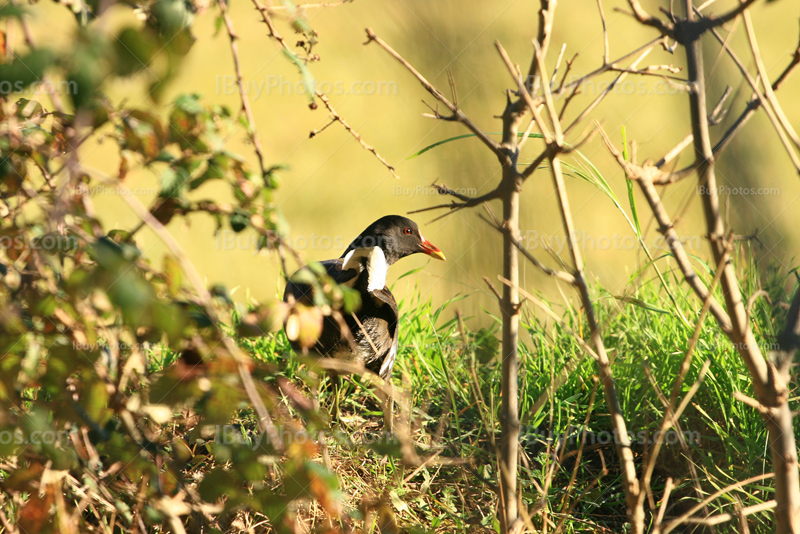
[0,0,800,533]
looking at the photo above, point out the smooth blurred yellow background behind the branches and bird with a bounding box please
[23,0,800,324]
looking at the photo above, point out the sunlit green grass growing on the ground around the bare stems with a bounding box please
[159,245,795,532]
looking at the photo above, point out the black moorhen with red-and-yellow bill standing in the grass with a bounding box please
[283,215,444,381]
